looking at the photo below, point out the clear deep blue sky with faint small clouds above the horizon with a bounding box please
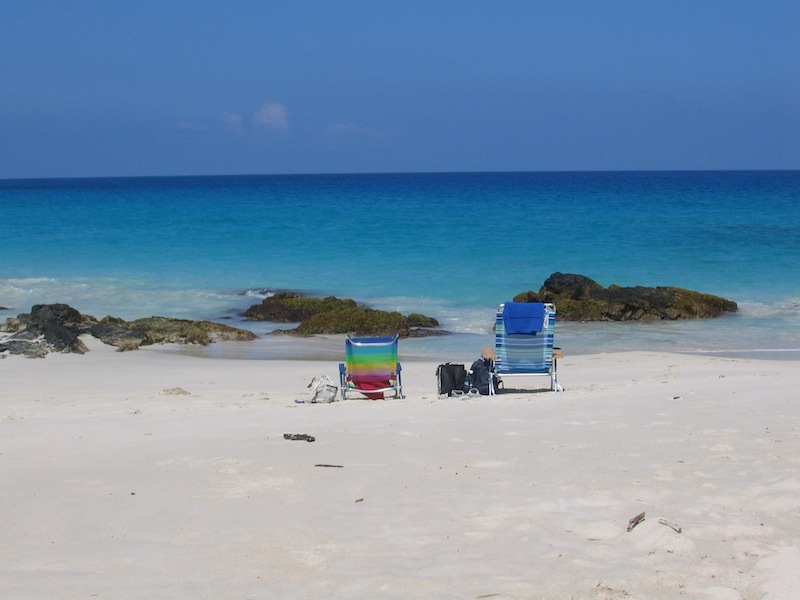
[0,0,800,179]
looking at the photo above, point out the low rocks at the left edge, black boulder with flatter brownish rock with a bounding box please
[0,304,257,357]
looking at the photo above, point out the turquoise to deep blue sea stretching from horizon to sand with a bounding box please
[0,171,800,360]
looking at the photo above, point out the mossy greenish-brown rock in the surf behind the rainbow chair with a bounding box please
[244,292,443,337]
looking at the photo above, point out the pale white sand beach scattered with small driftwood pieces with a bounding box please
[0,339,800,600]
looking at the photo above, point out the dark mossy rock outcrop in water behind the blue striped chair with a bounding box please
[514,273,738,321]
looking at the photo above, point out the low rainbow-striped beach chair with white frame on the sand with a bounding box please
[339,334,403,400]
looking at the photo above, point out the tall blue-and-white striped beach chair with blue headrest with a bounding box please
[490,302,564,392]
